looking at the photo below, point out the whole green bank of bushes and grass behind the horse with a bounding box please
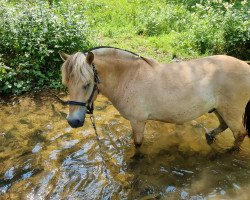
[0,0,250,93]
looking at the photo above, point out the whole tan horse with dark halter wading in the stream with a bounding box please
[60,46,250,152]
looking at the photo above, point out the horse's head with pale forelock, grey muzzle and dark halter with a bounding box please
[60,52,98,128]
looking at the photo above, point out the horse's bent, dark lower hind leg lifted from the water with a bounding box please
[206,110,228,145]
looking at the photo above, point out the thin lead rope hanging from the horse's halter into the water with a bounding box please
[90,114,111,199]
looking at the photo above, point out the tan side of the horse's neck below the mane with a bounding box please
[95,58,138,103]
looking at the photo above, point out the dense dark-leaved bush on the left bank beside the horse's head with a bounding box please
[0,0,90,94]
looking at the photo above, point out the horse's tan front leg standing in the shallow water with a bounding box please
[130,120,146,149]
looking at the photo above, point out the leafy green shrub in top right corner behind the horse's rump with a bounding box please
[188,0,250,59]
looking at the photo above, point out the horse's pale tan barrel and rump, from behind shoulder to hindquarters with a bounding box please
[139,55,250,123]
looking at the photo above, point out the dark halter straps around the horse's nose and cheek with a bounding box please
[67,64,100,114]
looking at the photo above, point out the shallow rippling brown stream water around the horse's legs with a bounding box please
[0,93,250,200]
